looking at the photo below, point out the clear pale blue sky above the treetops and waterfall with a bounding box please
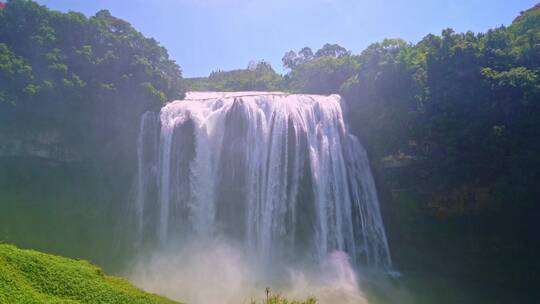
[38,0,539,77]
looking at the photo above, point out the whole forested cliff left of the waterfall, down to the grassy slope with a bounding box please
[0,0,184,269]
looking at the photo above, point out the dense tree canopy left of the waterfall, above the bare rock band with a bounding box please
[0,0,184,165]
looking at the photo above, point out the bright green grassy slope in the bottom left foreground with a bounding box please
[0,244,175,304]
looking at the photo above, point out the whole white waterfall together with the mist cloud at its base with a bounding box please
[131,92,391,304]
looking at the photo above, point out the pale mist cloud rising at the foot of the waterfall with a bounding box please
[131,240,367,304]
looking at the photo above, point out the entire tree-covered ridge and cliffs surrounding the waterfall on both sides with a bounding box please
[0,0,540,303]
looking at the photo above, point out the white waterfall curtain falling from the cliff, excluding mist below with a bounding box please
[135,92,391,269]
